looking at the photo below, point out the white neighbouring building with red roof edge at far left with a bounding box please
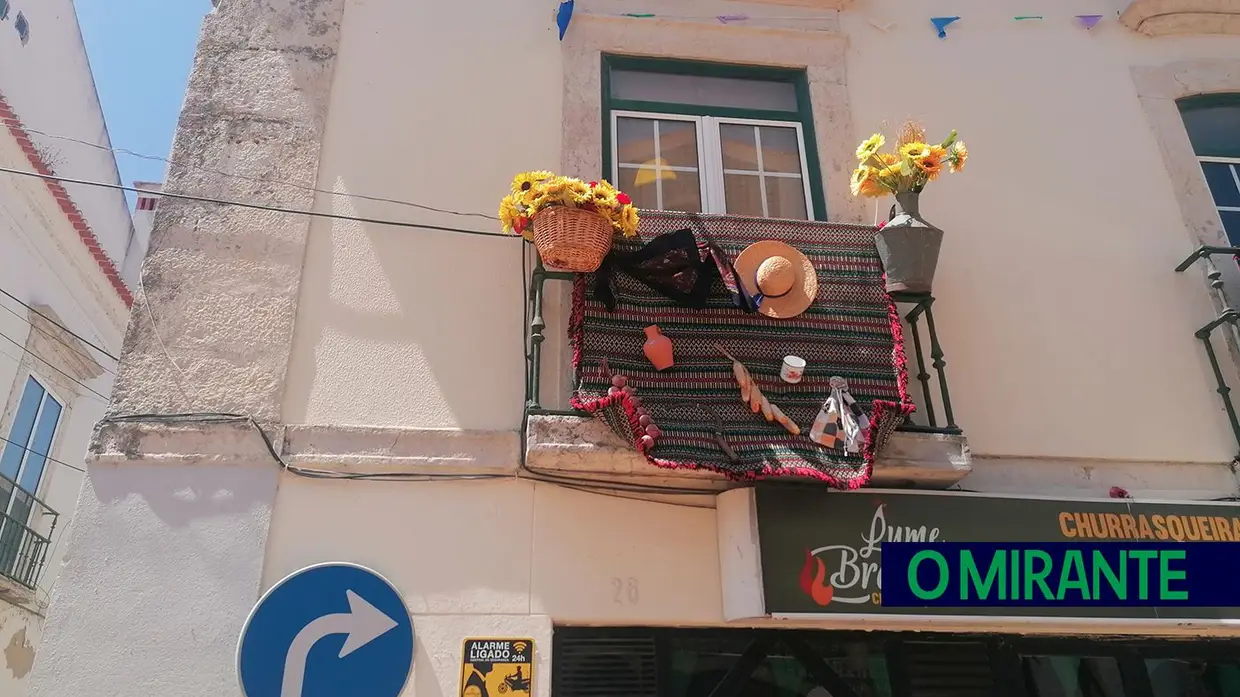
[0,0,150,697]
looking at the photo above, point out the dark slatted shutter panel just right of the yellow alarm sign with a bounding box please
[552,630,658,697]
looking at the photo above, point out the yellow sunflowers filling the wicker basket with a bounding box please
[500,171,637,239]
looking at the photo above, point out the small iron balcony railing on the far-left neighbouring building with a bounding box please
[0,475,60,590]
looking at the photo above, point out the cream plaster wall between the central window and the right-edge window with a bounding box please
[843,0,1236,461]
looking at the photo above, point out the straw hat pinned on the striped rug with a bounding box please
[733,239,818,319]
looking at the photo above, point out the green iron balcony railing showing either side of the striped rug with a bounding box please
[525,208,962,435]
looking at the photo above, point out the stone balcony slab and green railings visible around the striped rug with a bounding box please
[522,213,972,491]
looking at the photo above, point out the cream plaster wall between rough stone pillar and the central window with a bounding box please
[284,0,560,429]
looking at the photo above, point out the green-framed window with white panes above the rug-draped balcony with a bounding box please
[601,55,827,220]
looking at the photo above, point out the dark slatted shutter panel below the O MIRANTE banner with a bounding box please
[904,641,996,697]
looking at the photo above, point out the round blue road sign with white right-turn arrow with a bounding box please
[237,562,413,697]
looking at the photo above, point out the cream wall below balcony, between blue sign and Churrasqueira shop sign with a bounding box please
[263,475,722,659]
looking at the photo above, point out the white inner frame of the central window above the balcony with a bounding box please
[610,109,815,221]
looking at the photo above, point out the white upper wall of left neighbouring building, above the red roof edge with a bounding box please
[0,0,133,268]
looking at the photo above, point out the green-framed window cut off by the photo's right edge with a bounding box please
[1177,93,1240,244]
